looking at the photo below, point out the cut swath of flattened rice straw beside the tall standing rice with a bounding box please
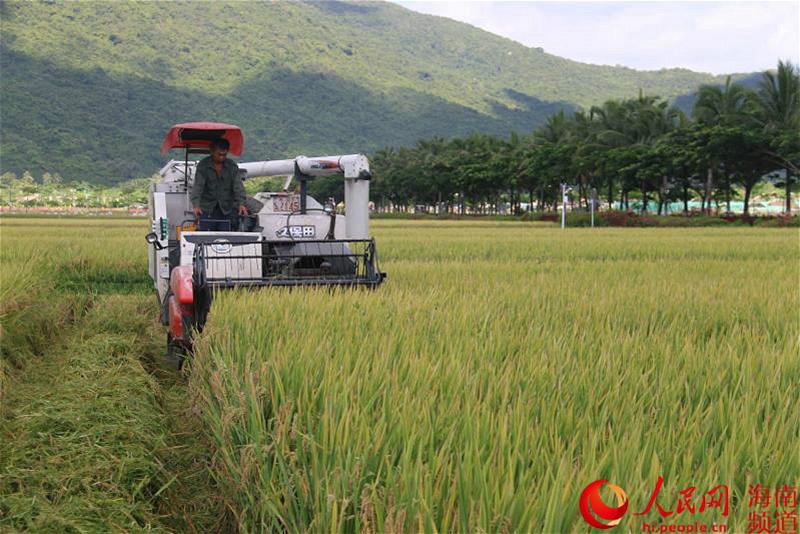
[0,296,224,532]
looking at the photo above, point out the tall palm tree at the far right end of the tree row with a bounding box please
[757,61,800,213]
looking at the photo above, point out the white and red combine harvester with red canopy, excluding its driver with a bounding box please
[147,122,386,361]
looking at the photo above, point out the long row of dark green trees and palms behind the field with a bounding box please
[372,61,800,214]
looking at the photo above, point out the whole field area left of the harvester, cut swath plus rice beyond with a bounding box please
[0,217,229,532]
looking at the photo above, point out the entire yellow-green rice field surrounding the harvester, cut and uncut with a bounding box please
[0,219,800,532]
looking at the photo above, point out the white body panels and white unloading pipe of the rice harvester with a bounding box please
[148,154,382,302]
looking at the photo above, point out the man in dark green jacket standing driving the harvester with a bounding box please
[190,138,248,232]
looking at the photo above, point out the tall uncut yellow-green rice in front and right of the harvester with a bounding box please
[190,220,800,532]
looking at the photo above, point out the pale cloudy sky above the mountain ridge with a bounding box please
[395,0,800,74]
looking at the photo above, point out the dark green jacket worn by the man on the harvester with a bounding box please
[190,156,245,215]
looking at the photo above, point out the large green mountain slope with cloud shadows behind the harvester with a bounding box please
[0,1,752,183]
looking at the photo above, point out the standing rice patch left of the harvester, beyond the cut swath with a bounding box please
[0,217,151,369]
